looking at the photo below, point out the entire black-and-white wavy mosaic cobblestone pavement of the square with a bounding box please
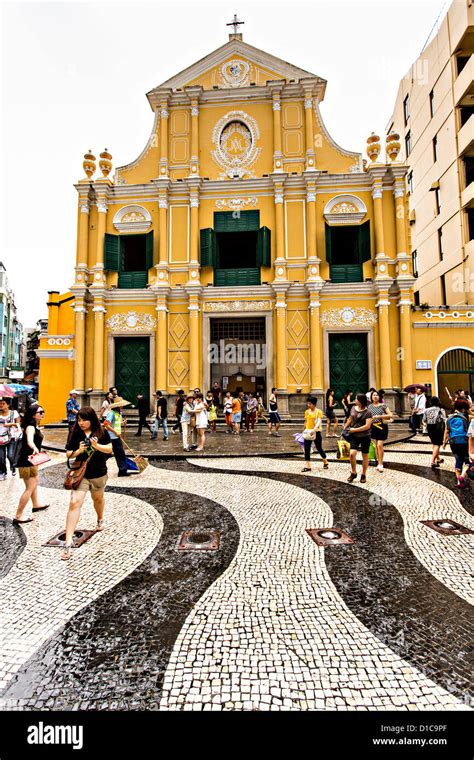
[0,442,474,710]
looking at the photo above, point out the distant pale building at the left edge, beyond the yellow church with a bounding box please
[0,262,23,383]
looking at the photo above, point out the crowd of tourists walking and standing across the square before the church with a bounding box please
[0,383,474,560]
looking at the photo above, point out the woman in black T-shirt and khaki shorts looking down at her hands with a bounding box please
[61,406,113,560]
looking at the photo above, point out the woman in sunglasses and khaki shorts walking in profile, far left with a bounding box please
[13,404,49,525]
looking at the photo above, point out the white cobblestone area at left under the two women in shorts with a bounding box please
[0,457,163,706]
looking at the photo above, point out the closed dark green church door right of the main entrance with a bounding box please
[329,333,369,401]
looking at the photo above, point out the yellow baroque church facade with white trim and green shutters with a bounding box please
[39,34,473,422]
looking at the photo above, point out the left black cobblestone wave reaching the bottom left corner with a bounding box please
[2,480,239,710]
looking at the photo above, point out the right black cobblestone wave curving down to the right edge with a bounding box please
[155,462,474,704]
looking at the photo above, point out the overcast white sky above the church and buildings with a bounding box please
[0,0,449,326]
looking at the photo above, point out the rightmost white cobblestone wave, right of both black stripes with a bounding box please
[190,454,474,604]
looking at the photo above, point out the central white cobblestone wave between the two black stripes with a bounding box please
[104,459,468,710]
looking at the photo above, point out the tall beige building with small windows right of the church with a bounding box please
[388,0,474,306]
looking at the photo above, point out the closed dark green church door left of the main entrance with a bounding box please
[115,338,150,405]
